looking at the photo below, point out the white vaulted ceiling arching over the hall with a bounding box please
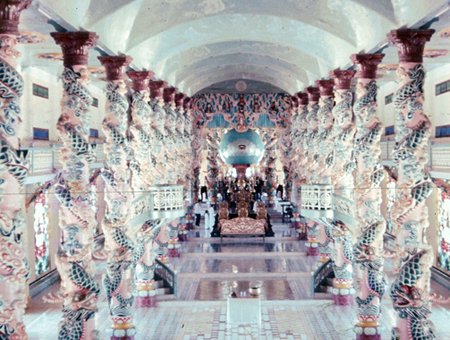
[30,0,447,95]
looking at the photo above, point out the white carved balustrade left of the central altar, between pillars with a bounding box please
[129,185,185,226]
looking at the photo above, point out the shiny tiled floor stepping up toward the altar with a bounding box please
[25,215,450,340]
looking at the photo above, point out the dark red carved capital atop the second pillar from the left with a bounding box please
[50,31,98,67]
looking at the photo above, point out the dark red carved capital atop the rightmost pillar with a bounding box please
[387,29,434,63]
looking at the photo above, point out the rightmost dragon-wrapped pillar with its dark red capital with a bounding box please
[388,29,436,340]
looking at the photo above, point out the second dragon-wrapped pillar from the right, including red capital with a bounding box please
[352,54,386,340]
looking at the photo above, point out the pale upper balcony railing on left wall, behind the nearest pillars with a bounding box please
[22,144,105,177]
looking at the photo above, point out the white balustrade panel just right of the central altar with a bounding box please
[300,184,333,220]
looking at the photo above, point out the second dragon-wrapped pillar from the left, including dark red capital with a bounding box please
[51,32,100,339]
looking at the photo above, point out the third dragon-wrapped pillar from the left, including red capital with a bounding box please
[99,56,135,340]
